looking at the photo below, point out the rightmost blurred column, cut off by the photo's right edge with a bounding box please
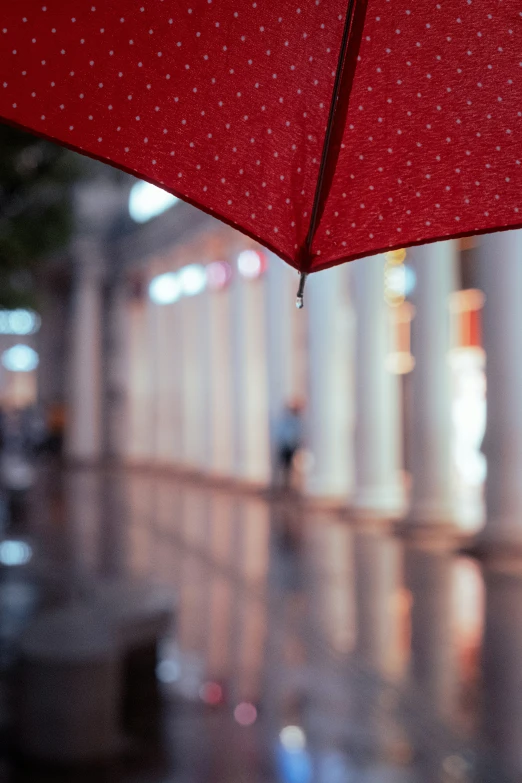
[476,231,522,544]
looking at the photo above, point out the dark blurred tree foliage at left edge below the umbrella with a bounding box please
[0,125,82,308]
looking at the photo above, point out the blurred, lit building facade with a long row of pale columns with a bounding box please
[30,173,510,541]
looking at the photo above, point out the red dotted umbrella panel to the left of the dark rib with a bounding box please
[0,0,345,260]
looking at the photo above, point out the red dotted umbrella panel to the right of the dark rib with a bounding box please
[313,0,522,269]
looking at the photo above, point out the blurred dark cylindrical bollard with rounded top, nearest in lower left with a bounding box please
[15,604,121,763]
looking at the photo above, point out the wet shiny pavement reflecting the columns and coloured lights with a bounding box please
[0,470,522,783]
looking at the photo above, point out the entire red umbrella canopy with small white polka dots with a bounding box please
[0,0,522,272]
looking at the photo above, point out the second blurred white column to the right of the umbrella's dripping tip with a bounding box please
[350,255,404,516]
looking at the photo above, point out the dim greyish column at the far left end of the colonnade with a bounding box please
[66,238,103,461]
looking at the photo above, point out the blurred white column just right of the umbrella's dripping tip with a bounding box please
[306,266,353,498]
